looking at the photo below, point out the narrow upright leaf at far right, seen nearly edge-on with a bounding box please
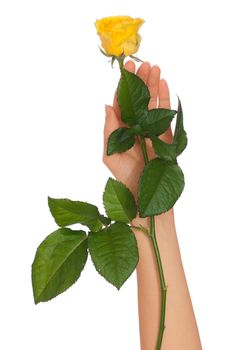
[173,97,188,155]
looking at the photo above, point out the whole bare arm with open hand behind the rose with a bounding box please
[103,61,201,350]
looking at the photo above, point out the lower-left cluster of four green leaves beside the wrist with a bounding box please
[32,178,139,304]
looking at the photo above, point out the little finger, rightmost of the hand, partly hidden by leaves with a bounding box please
[158,79,173,143]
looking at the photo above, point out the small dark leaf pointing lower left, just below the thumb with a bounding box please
[107,128,135,156]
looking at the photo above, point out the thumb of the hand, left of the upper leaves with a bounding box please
[103,105,121,163]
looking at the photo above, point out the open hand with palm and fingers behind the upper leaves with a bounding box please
[103,61,172,198]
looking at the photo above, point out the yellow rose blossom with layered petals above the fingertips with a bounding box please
[95,16,144,57]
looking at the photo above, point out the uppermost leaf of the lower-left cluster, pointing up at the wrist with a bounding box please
[103,178,137,223]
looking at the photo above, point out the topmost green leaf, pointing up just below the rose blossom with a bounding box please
[118,69,150,126]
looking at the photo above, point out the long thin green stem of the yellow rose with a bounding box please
[141,137,167,350]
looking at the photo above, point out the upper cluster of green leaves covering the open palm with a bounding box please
[107,68,187,217]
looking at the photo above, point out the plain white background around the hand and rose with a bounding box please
[0,0,232,350]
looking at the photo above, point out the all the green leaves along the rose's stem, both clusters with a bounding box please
[32,68,187,304]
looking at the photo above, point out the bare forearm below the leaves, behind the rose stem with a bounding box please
[133,210,201,350]
